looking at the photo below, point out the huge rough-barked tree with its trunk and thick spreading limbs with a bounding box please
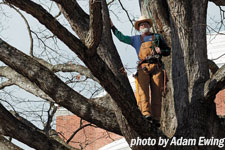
[0,0,225,150]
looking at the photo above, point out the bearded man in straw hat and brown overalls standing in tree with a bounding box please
[111,16,170,127]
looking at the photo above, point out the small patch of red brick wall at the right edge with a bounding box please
[214,89,225,116]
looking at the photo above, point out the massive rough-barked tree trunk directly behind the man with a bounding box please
[140,0,224,149]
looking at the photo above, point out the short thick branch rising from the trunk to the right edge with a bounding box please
[204,65,225,100]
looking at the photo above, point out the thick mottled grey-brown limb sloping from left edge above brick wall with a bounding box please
[0,39,120,134]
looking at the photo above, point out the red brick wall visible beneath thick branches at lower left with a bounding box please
[56,115,122,150]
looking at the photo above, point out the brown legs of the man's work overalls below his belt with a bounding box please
[137,64,163,120]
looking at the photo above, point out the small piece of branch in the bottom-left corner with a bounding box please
[0,135,23,150]
